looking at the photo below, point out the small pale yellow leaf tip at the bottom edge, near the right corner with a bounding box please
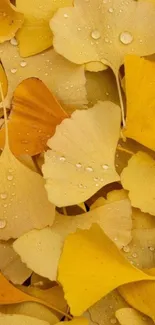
[116,308,154,325]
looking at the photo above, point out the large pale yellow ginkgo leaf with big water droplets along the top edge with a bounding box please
[50,0,155,73]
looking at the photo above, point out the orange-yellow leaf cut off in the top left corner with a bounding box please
[0,0,24,43]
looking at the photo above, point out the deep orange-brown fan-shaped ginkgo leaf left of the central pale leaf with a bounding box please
[0,78,68,156]
